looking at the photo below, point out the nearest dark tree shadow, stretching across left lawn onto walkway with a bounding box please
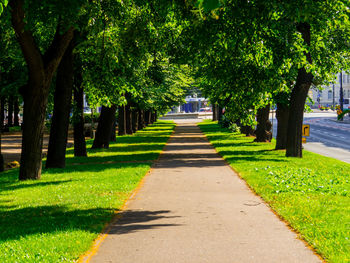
[0,206,180,242]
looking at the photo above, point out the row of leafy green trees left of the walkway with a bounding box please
[0,0,192,180]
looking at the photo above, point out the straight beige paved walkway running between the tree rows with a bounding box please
[91,123,321,263]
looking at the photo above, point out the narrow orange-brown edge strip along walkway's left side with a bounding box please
[76,123,177,263]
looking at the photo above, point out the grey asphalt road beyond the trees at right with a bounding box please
[273,113,350,163]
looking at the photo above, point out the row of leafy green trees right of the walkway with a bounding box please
[179,0,350,157]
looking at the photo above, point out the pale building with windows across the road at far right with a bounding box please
[309,72,350,108]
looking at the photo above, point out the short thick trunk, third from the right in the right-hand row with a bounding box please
[254,105,272,142]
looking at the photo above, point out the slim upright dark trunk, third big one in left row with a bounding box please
[73,84,87,157]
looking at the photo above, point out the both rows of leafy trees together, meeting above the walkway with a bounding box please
[0,0,350,179]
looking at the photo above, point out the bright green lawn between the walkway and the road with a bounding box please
[199,121,350,263]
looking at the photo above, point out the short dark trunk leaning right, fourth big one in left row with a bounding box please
[91,104,117,149]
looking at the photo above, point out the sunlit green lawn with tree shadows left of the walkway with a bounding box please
[0,121,175,262]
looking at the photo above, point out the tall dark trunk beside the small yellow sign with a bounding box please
[286,23,313,157]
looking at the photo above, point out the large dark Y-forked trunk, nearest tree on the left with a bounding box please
[9,0,74,180]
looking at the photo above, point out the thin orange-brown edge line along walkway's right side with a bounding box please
[197,124,327,263]
